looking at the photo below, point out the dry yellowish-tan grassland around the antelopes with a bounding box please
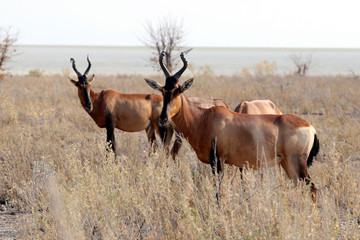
[0,64,360,239]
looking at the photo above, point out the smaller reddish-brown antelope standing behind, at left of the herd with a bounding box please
[69,57,173,154]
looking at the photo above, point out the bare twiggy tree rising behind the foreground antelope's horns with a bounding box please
[143,18,184,73]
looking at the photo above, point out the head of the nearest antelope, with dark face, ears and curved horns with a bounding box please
[145,49,194,126]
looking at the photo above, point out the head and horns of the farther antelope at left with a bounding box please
[68,56,95,112]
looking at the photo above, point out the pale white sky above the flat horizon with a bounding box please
[0,0,360,48]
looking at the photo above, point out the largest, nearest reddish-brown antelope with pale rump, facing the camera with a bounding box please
[145,53,319,200]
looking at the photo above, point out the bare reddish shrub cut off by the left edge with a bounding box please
[0,28,17,81]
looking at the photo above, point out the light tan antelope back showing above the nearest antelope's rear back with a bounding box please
[234,100,282,115]
